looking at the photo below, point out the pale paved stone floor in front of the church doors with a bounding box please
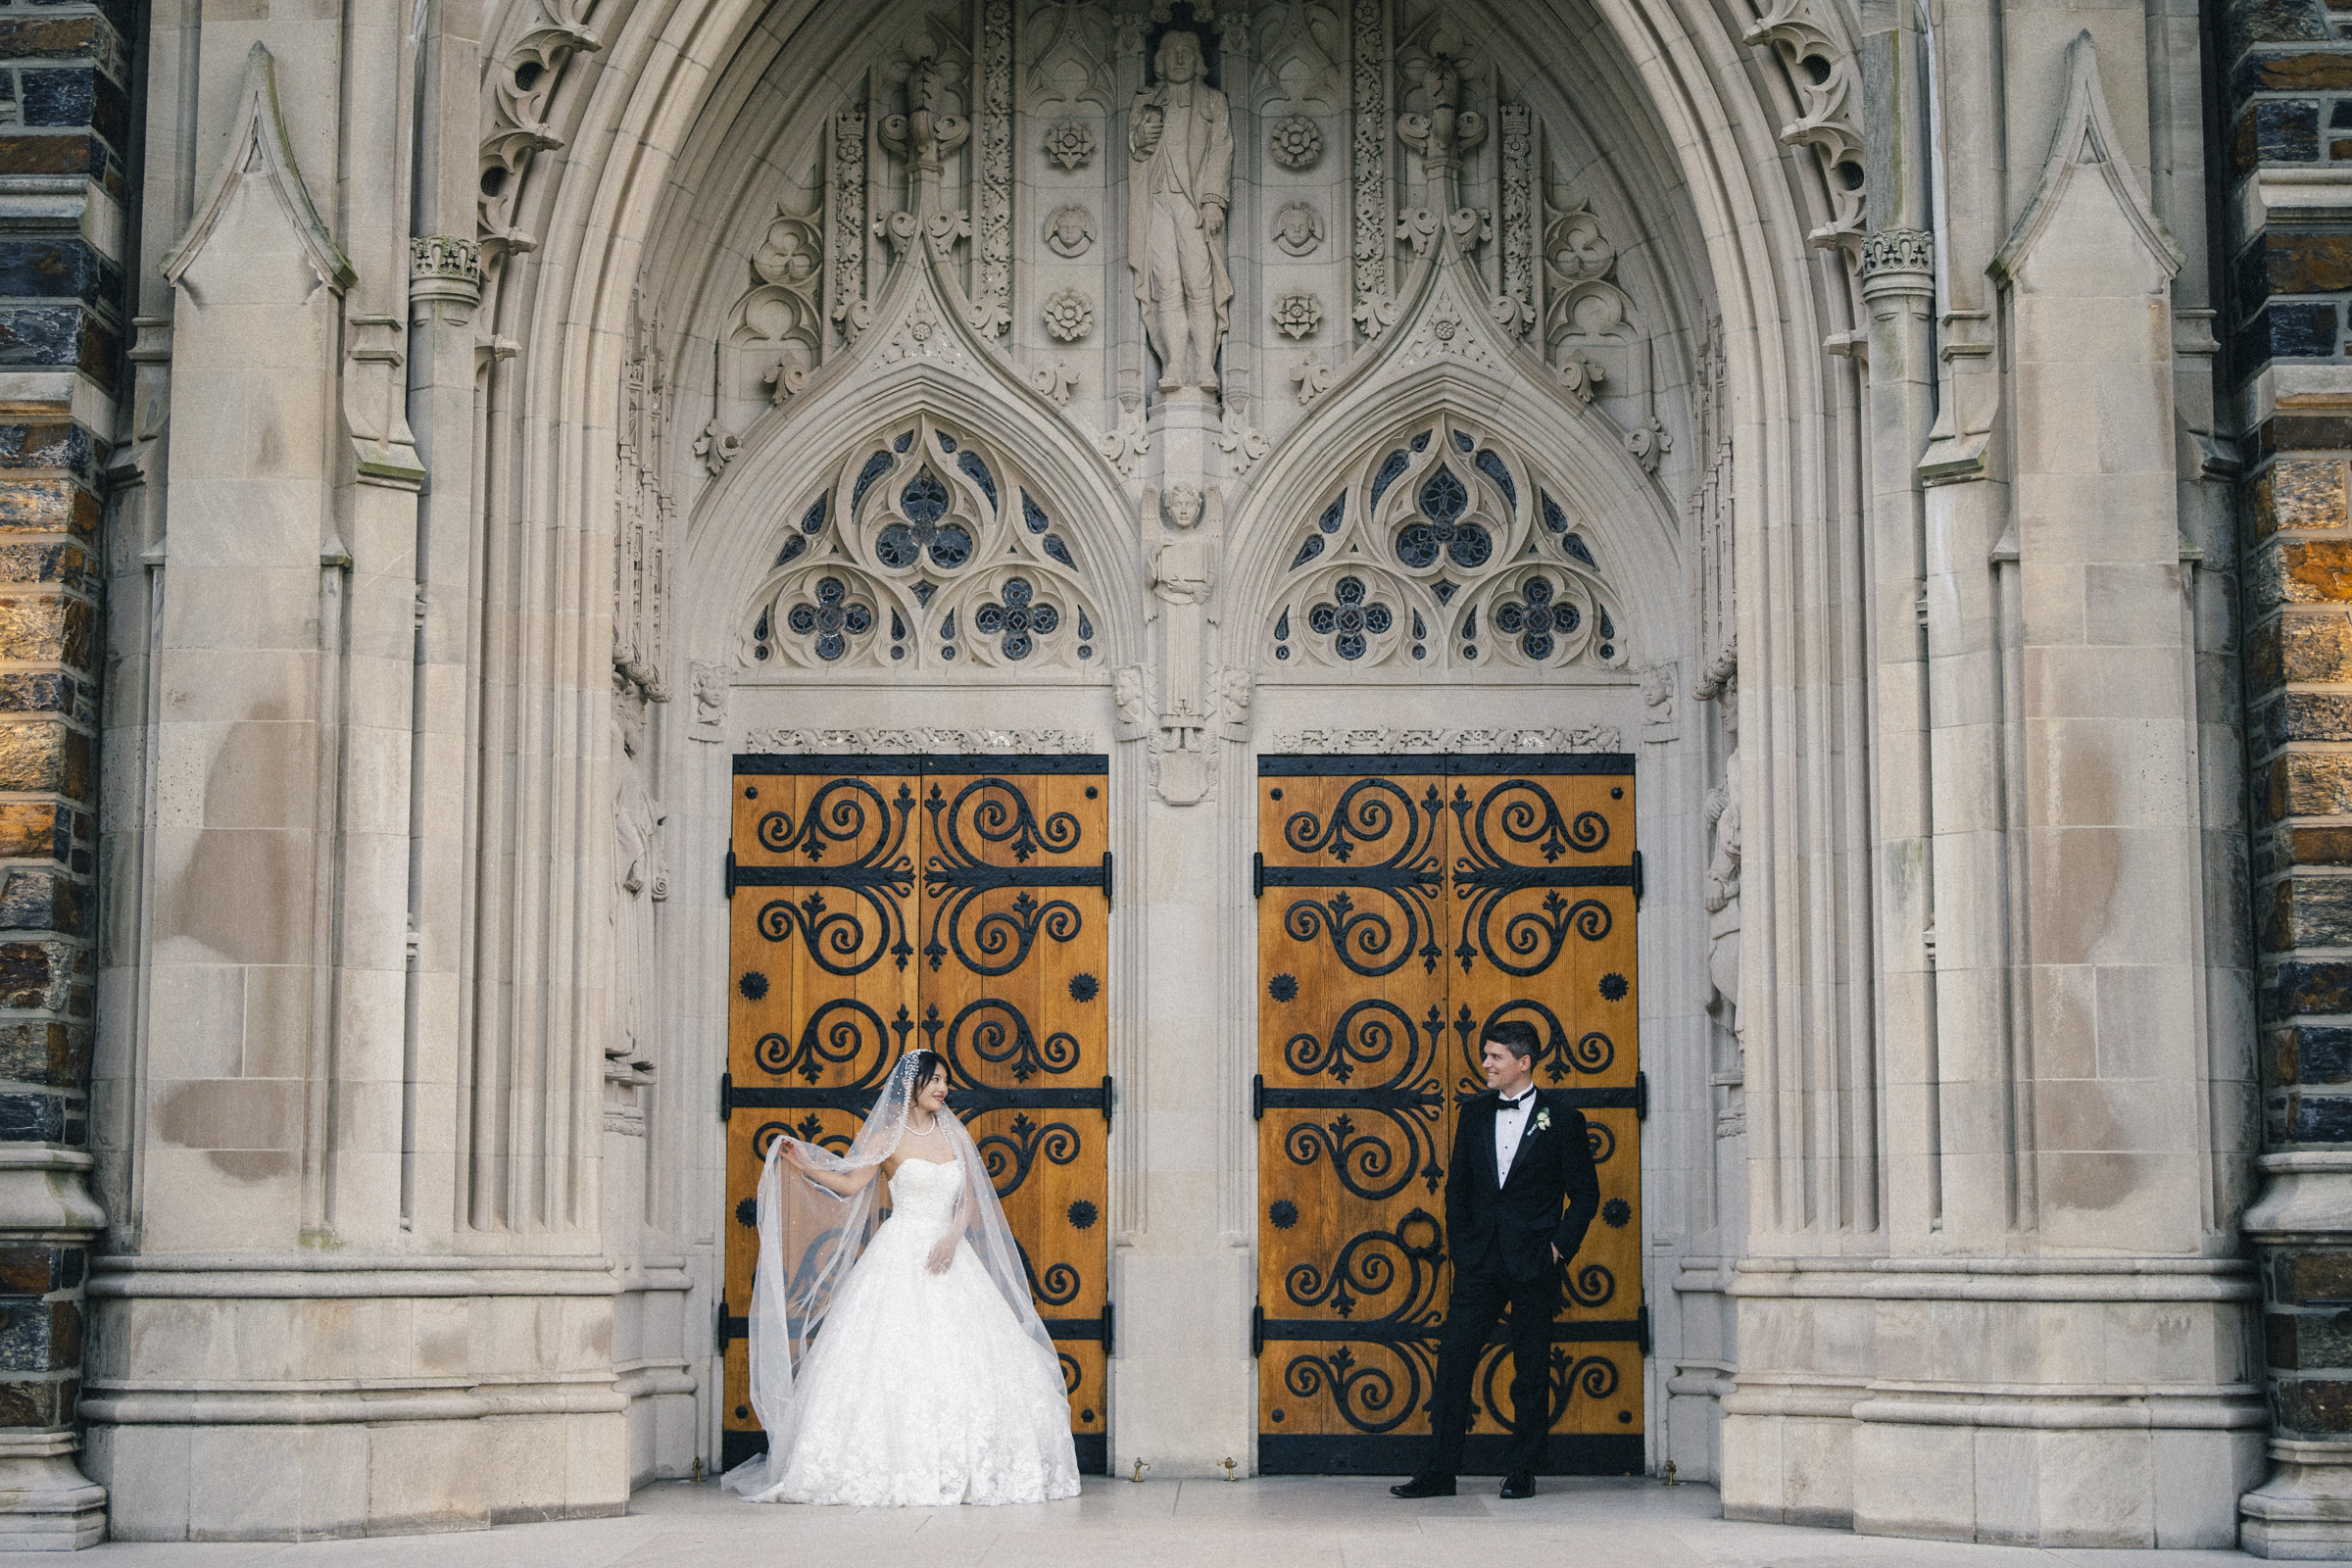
[55,1479,2332,1568]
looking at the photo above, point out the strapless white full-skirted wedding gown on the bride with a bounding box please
[753,1159,1077,1507]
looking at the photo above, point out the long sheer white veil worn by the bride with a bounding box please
[719,1051,1063,1493]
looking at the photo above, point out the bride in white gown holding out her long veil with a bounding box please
[724,1051,1077,1507]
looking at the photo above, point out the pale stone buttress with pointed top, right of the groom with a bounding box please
[1853,30,2260,1546]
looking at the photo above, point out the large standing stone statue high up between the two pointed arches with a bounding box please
[1127,33,1233,393]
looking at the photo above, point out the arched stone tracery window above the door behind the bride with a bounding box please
[736,418,1103,674]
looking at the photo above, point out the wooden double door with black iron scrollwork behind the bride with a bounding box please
[719,755,1112,1474]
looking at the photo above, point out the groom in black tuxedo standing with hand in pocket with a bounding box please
[1388,1018,1601,1497]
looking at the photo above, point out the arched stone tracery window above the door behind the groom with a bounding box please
[1260,420,1628,672]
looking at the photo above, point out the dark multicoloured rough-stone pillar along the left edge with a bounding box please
[0,5,131,1549]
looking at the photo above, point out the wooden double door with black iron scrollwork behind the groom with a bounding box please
[1253,753,1648,1474]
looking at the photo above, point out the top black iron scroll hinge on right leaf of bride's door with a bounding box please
[922,778,1103,976]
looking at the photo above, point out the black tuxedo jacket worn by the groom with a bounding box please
[1446,1089,1601,1281]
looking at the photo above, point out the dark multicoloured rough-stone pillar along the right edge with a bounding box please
[2213,0,2352,1558]
